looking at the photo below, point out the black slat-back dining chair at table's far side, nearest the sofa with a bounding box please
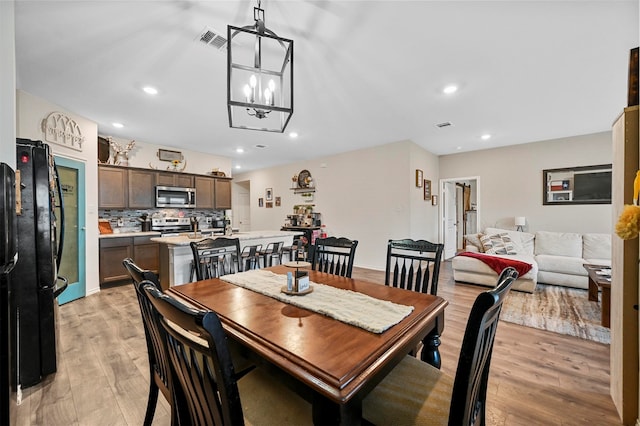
[384,239,444,296]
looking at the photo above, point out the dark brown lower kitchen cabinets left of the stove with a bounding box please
[99,236,160,285]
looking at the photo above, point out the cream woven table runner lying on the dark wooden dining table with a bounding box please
[220,269,413,334]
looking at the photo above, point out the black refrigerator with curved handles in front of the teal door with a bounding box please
[9,139,66,390]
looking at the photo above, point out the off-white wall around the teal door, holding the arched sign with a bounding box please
[13,90,100,295]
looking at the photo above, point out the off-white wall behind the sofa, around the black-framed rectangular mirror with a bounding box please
[440,132,612,233]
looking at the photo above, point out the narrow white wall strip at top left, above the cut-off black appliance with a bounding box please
[0,1,16,169]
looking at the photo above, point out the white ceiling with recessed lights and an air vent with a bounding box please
[15,0,639,173]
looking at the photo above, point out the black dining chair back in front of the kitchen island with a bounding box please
[190,237,240,281]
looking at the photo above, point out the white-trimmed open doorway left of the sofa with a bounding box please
[440,176,480,259]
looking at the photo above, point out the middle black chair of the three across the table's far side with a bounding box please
[311,237,358,278]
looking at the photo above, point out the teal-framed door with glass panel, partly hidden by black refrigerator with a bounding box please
[55,157,86,305]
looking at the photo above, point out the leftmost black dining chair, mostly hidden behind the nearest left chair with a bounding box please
[122,258,178,426]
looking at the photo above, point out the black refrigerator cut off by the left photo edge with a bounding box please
[0,163,17,425]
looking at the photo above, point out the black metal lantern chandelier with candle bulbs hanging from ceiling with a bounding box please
[227,0,293,133]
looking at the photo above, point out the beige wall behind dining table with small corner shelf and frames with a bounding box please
[234,141,437,269]
